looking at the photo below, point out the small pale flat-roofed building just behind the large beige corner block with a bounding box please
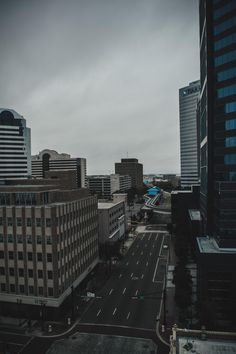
[98,201,126,243]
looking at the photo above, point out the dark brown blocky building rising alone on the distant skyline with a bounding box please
[115,158,143,189]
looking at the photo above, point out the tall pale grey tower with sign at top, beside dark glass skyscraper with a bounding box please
[179,81,200,188]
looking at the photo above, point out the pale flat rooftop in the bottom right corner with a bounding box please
[177,337,236,354]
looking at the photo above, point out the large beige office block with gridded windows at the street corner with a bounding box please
[0,171,98,318]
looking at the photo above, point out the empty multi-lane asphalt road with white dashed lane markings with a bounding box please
[80,232,167,330]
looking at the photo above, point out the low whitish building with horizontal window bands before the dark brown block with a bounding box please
[87,174,131,199]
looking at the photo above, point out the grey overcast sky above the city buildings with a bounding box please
[0,0,199,174]
